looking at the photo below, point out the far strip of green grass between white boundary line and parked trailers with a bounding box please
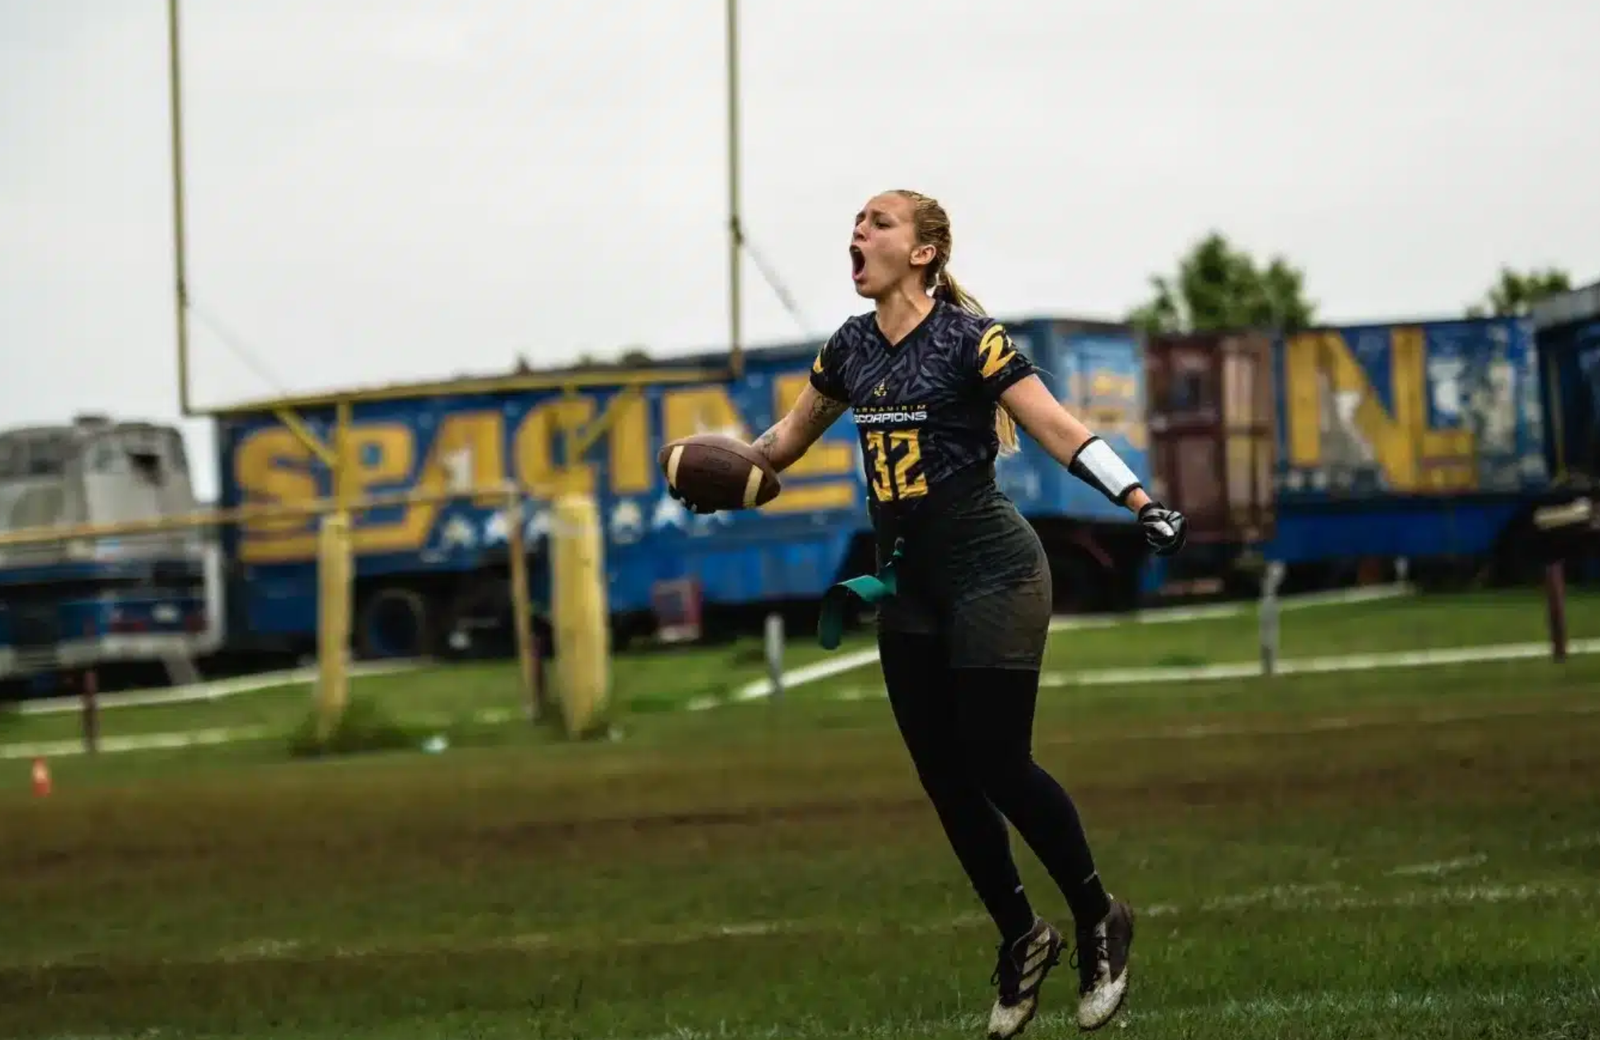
[0,592,1600,742]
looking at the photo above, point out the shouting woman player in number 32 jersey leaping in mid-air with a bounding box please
[668,190,1186,1040]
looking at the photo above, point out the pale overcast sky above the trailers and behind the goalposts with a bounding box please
[0,0,1600,494]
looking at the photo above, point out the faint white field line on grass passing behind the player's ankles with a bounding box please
[15,882,1600,968]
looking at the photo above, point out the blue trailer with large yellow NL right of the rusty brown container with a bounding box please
[1150,318,1566,584]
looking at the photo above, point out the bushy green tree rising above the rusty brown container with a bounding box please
[1128,230,1317,333]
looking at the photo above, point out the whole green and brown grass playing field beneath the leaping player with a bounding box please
[0,595,1600,1040]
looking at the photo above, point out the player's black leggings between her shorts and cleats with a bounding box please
[878,632,1110,941]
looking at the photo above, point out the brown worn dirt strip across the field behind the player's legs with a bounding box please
[0,704,1600,888]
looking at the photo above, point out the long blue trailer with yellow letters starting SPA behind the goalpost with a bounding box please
[218,320,1155,656]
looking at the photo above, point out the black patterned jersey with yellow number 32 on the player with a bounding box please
[811,301,1035,520]
